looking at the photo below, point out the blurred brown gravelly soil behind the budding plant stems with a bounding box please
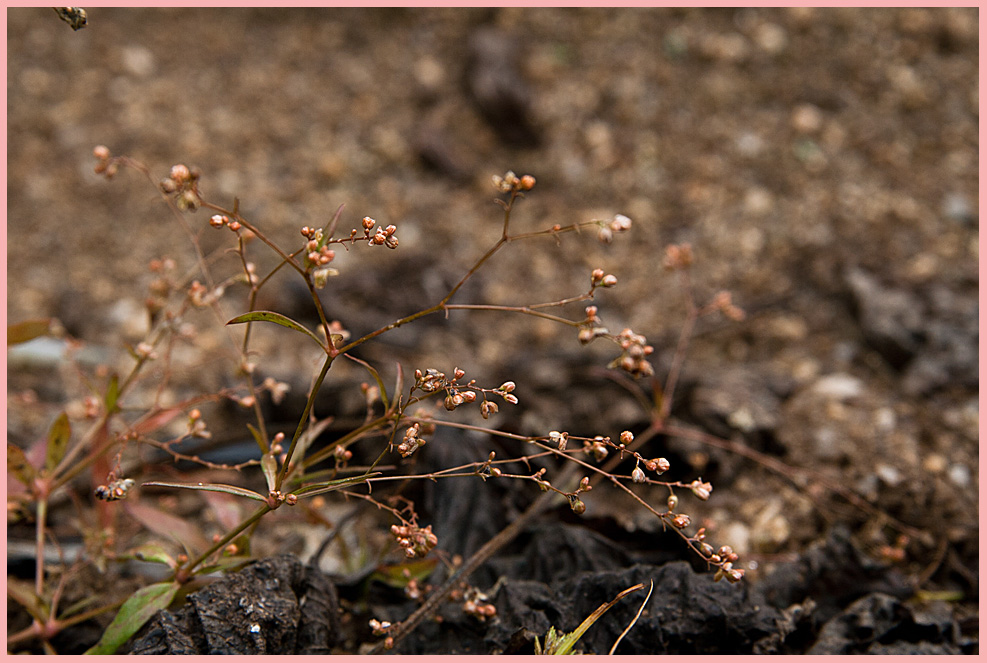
[7,8,979,656]
